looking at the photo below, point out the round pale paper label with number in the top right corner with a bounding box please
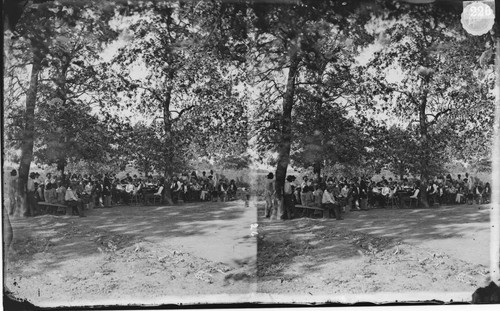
[462,2,495,36]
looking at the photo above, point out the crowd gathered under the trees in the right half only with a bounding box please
[264,173,491,220]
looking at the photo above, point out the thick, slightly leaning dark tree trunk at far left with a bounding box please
[16,48,42,216]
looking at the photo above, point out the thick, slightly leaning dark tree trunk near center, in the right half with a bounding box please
[276,50,299,218]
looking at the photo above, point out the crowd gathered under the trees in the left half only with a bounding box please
[4,170,243,217]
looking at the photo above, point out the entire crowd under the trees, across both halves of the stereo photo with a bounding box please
[5,166,491,220]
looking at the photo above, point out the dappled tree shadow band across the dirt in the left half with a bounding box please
[7,201,251,273]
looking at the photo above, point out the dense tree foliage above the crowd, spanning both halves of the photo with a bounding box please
[4,0,494,214]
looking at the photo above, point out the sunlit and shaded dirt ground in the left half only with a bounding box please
[4,201,256,306]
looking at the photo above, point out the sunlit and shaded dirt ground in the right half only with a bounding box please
[257,205,490,302]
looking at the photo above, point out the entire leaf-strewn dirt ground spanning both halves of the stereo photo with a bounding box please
[4,201,490,307]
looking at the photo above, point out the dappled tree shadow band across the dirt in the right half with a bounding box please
[257,204,489,280]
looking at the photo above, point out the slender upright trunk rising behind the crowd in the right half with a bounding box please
[419,82,430,208]
